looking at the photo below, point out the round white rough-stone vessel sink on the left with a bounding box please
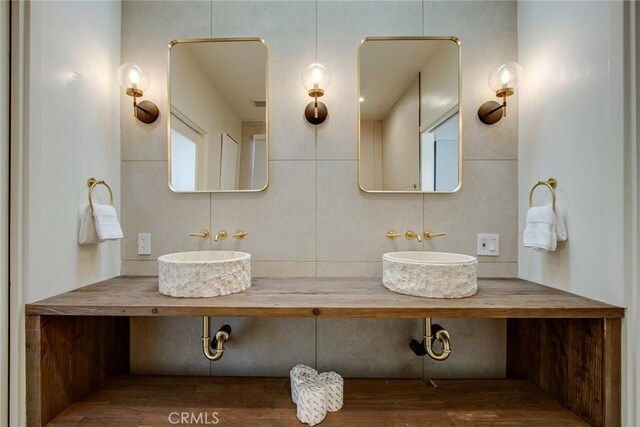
[158,251,251,297]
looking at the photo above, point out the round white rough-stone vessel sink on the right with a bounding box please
[382,252,478,298]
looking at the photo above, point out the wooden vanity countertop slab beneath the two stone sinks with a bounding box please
[26,277,624,318]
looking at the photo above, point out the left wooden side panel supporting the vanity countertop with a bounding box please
[26,316,129,427]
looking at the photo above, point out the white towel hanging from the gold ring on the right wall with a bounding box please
[522,205,567,251]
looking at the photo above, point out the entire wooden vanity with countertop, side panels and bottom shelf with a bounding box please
[25,277,624,427]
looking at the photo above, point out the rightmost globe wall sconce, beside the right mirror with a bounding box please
[478,62,522,125]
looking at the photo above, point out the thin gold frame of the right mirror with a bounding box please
[355,36,463,194]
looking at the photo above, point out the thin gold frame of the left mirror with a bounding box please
[166,37,270,194]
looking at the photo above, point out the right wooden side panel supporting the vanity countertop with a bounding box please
[507,319,621,427]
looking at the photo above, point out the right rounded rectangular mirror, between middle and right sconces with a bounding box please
[358,37,462,193]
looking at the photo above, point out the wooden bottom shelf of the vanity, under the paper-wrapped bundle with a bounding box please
[48,376,587,427]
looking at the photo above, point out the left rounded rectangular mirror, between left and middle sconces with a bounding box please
[168,39,269,192]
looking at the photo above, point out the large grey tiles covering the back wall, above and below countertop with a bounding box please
[121,1,518,377]
